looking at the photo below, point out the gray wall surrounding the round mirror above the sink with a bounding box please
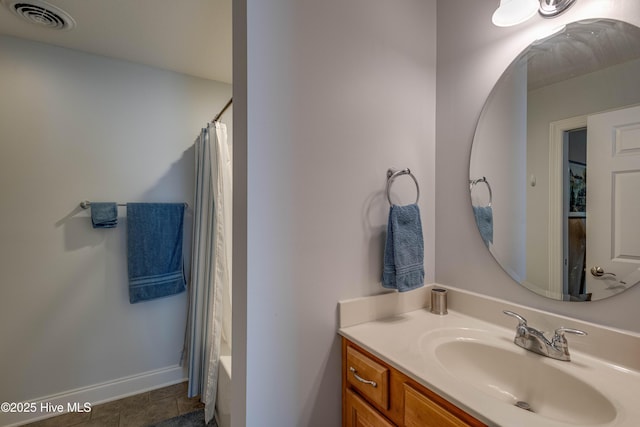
[436,0,640,332]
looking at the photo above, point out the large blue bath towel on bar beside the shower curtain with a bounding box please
[127,203,186,304]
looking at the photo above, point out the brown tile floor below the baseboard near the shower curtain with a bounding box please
[25,382,204,427]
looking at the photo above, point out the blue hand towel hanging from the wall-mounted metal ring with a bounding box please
[382,204,424,292]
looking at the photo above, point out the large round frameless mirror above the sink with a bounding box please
[469,19,640,301]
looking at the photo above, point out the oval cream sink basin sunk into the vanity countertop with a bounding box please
[420,328,617,426]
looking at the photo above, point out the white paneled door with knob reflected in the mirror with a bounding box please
[585,106,640,299]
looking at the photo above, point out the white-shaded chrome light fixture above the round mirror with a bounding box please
[491,0,576,27]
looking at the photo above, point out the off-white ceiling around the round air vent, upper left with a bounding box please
[0,0,232,83]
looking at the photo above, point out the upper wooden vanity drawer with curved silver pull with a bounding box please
[346,346,389,409]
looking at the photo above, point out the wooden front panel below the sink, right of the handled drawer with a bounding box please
[404,383,469,427]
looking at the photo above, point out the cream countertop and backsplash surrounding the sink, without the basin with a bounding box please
[339,287,640,427]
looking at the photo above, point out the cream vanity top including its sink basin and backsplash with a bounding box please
[340,289,640,427]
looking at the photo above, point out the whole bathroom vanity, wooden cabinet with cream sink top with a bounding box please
[338,287,640,427]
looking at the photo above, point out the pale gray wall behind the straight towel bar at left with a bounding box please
[0,37,231,416]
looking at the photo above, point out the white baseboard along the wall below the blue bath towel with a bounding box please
[0,365,186,427]
